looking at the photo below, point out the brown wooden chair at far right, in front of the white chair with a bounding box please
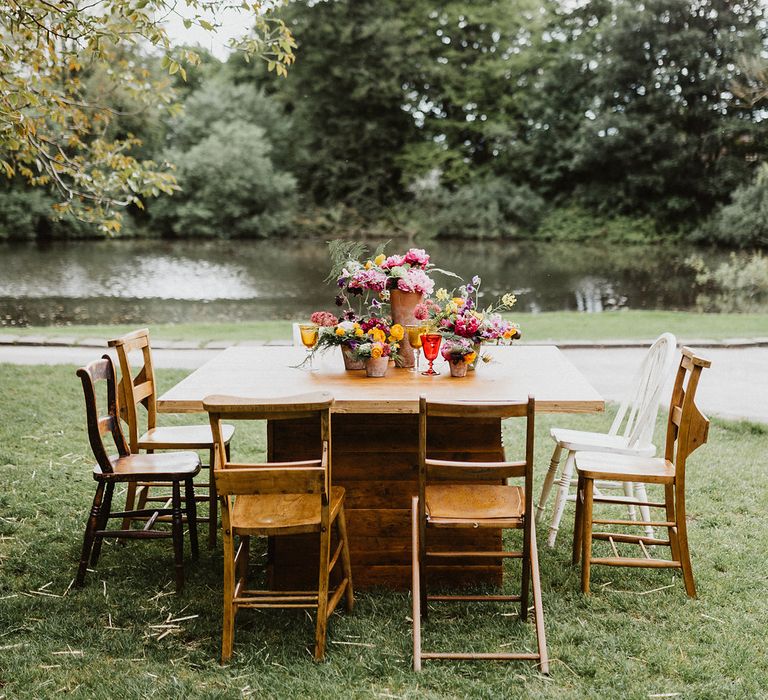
[573,348,711,598]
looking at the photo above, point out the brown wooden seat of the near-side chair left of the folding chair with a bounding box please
[232,486,344,535]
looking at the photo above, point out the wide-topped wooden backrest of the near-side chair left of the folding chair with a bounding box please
[203,392,333,525]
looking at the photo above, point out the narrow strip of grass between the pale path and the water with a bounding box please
[2,311,768,344]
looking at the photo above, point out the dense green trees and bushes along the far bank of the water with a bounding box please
[0,0,768,246]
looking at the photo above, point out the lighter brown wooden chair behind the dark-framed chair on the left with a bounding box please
[107,328,235,547]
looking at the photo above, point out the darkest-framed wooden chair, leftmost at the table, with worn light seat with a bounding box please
[75,355,200,591]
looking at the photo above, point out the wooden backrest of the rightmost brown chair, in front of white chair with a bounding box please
[664,348,712,490]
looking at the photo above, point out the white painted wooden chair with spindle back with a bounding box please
[536,333,677,547]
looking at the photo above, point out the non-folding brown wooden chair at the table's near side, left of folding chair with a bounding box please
[203,393,355,663]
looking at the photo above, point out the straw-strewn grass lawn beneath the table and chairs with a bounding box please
[0,364,768,700]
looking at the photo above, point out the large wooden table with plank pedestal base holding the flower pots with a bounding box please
[158,345,604,588]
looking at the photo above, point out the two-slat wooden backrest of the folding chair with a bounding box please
[419,396,536,515]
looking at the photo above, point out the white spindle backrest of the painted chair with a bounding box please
[608,333,677,445]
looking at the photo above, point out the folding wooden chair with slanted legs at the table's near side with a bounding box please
[411,396,549,674]
